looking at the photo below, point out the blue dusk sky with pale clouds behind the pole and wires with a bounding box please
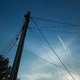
[0,0,80,80]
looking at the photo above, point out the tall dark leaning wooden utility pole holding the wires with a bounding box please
[10,11,30,80]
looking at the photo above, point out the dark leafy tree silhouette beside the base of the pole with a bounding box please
[0,55,11,80]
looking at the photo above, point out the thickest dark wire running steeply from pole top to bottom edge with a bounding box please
[31,18,75,80]
